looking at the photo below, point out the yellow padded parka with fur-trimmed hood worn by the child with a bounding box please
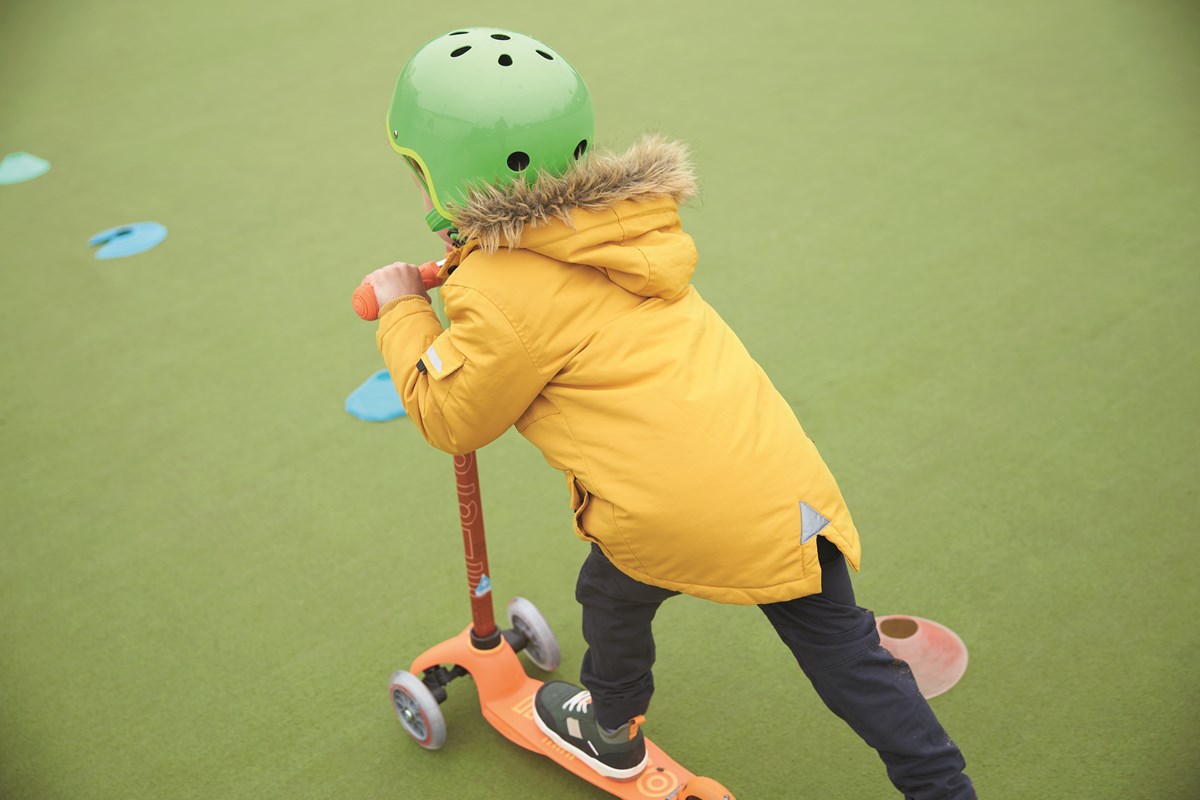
[377,137,859,603]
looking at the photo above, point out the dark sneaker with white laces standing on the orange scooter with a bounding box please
[533,680,648,781]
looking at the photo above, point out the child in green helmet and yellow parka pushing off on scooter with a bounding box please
[366,29,976,800]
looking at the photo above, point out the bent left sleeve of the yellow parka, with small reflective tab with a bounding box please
[376,284,546,453]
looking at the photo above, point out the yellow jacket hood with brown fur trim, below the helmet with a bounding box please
[452,136,696,299]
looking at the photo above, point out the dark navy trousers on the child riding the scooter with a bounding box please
[575,537,976,800]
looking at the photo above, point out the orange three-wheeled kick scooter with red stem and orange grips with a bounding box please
[354,263,734,800]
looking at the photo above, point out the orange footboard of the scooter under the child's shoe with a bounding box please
[410,626,695,800]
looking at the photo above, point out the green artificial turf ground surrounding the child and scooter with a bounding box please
[0,0,1200,800]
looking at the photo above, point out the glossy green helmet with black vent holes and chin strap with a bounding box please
[388,28,594,230]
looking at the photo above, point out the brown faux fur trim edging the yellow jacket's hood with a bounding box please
[450,134,696,252]
